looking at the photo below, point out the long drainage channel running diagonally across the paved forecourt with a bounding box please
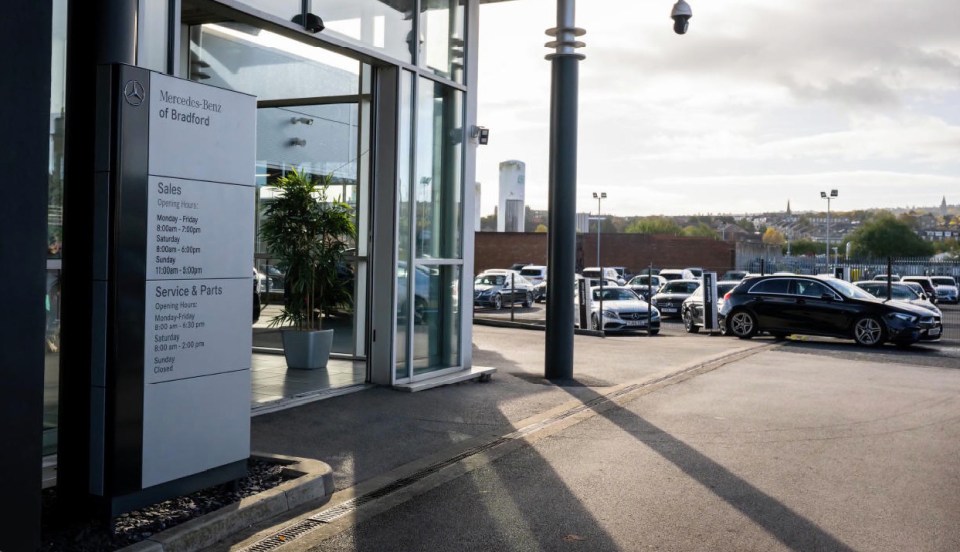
[243,347,768,552]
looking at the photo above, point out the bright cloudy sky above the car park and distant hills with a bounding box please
[477,0,960,216]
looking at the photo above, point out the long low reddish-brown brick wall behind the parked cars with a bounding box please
[475,232,736,274]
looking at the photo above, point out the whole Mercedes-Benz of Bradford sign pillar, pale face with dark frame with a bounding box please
[89,65,256,515]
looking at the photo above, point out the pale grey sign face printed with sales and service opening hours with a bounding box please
[141,73,256,487]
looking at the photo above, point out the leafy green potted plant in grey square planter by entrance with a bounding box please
[260,166,356,369]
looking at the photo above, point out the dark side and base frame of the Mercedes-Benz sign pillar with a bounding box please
[81,64,247,517]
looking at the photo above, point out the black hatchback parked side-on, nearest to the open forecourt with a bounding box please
[720,275,935,347]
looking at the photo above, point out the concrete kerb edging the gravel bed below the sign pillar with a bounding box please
[121,453,333,552]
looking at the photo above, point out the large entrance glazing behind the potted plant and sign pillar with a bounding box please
[185,22,373,378]
